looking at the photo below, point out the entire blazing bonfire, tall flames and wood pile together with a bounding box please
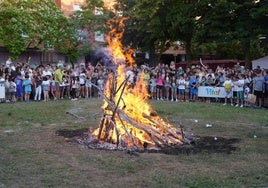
[83,6,191,151]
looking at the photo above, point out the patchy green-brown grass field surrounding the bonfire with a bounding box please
[0,99,268,188]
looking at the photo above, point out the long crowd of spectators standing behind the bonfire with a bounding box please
[0,60,268,107]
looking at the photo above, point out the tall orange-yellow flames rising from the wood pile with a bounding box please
[93,0,182,148]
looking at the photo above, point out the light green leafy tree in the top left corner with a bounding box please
[0,0,68,58]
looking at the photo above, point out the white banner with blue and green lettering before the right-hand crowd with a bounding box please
[198,86,226,98]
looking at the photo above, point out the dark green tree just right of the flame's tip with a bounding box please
[114,0,202,66]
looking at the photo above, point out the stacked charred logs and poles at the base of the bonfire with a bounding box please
[81,72,188,151]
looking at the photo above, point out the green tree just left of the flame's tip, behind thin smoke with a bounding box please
[56,0,110,64]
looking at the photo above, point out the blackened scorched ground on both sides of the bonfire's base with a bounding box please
[56,128,240,155]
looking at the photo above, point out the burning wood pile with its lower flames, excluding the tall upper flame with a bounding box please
[80,68,191,151]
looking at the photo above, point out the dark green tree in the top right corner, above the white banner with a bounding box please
[198,0,268,67]
